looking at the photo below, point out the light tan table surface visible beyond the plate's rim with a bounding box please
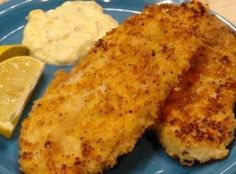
[0,0,236,24]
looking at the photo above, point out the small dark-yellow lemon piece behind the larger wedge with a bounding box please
[0,45,29,62]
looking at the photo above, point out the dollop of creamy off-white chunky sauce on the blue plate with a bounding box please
[22,1,118,65]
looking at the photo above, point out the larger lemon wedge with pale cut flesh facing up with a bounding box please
[0,56,44,138]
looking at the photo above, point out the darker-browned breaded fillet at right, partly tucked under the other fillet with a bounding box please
[157,10,236,165]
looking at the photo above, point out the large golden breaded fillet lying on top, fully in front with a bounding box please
[19,1,213,174]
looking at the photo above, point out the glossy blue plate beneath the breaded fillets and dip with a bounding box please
[0,0,236,174]
